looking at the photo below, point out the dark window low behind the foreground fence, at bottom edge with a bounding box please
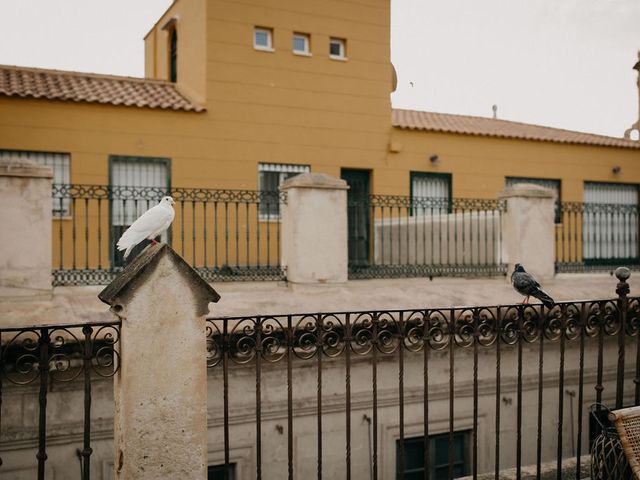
[396,430,471,480]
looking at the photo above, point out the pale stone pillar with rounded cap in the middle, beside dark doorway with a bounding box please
[280,173,349,283]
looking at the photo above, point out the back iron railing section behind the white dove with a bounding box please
[53,185,286,285]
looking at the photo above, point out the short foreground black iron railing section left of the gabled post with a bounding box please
[0,322,120,480]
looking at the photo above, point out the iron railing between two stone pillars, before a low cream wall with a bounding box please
[348,195,506,278]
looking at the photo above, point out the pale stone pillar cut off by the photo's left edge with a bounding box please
[0,158,53,299]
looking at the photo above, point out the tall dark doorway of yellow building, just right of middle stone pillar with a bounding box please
[340,169,371,267]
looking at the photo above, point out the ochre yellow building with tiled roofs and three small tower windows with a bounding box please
[0,0,640,283]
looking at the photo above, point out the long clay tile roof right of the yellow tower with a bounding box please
[391,109,640,149]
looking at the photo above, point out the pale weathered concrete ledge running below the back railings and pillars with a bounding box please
[0,272,640,327]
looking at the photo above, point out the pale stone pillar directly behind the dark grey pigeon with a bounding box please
[500,184,555,280]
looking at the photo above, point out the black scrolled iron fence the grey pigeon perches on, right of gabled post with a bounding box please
[207,271,640,480]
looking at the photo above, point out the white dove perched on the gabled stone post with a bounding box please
[117,197,176,259]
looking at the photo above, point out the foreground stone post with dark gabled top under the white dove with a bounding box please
[99,244,220,480]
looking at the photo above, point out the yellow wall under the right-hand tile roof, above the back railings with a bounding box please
[384,128,640,202]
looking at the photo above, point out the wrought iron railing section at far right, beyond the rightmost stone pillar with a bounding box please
[556,202,640,272]
